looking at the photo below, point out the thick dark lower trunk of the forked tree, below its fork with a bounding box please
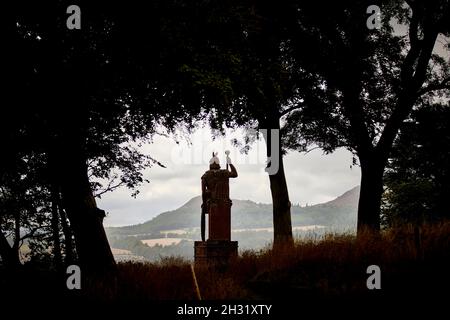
[358,157,385,234]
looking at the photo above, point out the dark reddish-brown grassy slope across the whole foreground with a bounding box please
[0,222,450,310]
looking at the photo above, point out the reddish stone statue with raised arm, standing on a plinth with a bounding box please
[201,151,238,241]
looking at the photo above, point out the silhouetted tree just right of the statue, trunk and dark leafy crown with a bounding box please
[174,1,308,247]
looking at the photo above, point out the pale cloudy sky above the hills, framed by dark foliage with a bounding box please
[98,129,360,226]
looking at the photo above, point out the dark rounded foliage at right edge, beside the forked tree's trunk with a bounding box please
[382,103,450,227]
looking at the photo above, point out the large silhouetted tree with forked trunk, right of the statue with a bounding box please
[284,1,450,231]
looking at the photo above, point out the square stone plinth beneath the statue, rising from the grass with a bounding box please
[194,240,238,267]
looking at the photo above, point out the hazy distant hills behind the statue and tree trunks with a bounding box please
[107,187,359,235]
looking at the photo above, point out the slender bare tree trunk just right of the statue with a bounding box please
[262,121,293,248]
